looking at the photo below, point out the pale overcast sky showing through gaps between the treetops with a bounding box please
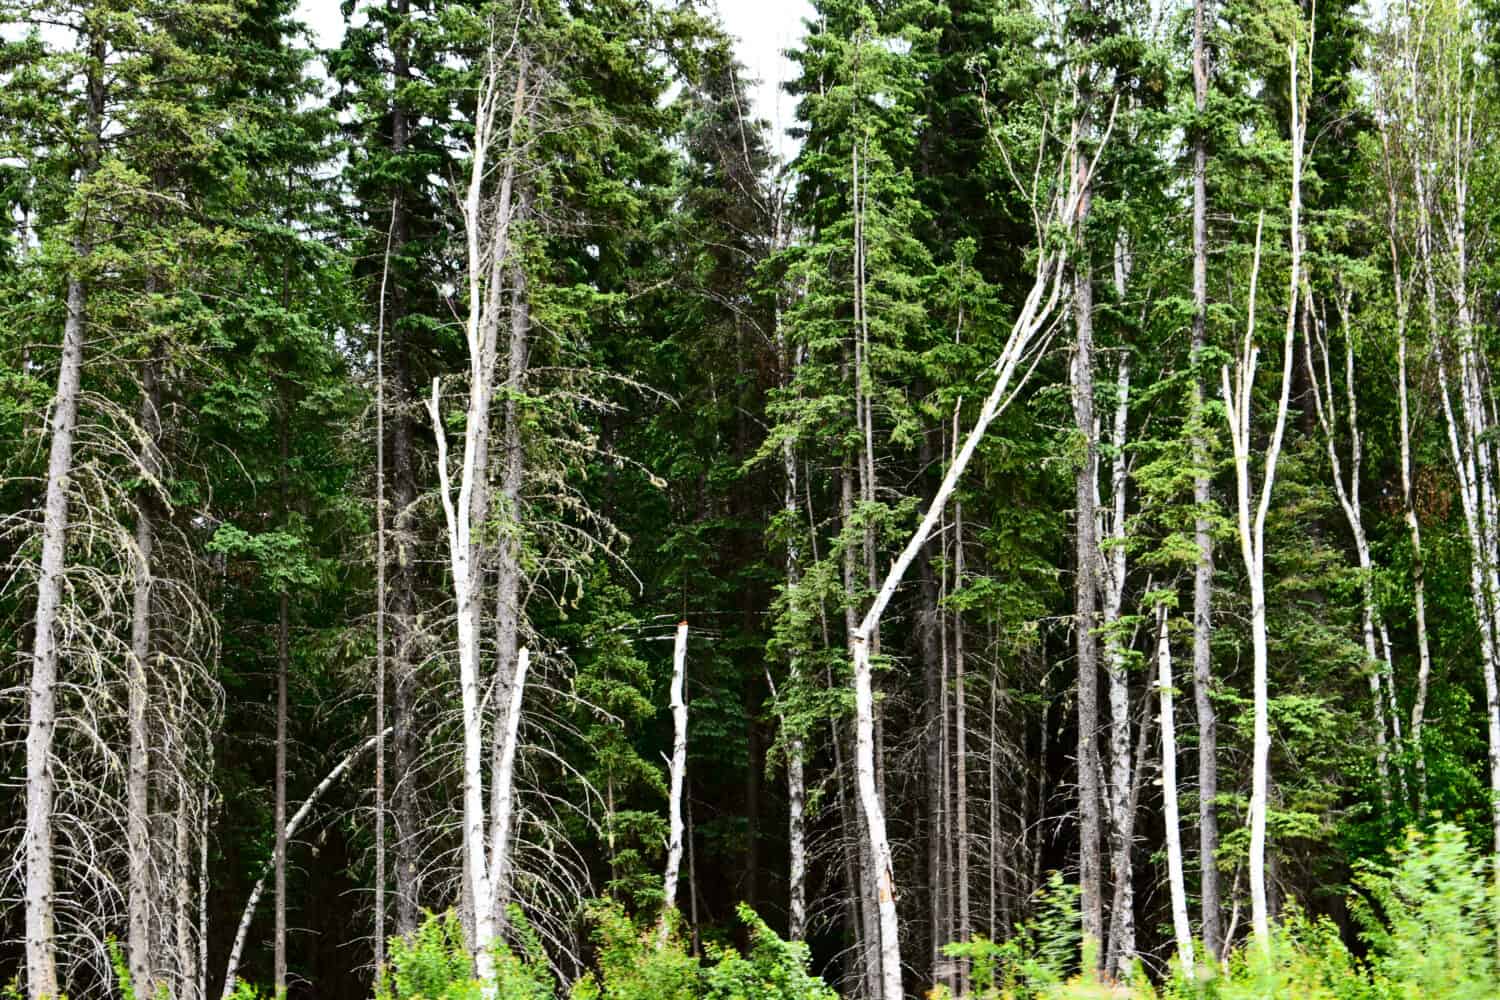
[299,0,812,156]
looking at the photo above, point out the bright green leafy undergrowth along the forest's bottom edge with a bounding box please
[372,826,1500,1000]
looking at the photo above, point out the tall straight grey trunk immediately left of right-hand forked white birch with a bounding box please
[1191,0,1223,960]
